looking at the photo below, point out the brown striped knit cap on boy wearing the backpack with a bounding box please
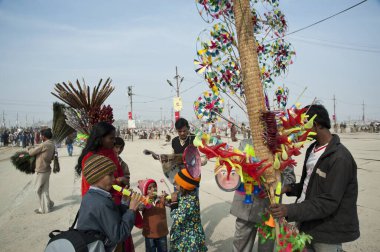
[83,154,116,185]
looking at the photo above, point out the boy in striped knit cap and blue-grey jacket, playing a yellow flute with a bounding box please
[77,154,141,251]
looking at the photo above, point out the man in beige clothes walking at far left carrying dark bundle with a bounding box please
[28,129,55,214]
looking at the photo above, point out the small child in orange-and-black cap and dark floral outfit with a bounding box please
[170,169,207,251]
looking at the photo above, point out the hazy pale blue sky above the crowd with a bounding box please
[0,0,380,125]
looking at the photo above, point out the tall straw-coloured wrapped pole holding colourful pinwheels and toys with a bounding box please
[233,0,279,243]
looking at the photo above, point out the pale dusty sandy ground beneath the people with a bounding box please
[0,134,380,252]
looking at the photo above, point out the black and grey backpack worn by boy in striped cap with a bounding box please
[45,211,107,252]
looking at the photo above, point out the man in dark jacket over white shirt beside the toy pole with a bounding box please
[270,105,360,252]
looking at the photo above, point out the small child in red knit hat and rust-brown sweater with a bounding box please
[138,179,169,252]
